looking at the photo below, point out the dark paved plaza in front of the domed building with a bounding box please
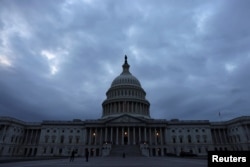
[0,157,207,167]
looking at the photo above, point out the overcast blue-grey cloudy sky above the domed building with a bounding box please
[0,0,250,121]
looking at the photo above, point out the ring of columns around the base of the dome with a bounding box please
[103,102,149,114]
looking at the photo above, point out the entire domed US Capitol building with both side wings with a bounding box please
[0,56,250,157]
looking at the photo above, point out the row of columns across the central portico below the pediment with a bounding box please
[86,127,164,145]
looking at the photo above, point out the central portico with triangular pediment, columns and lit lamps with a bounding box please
[85,114,166,156]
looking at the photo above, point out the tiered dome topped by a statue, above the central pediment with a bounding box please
[102,55,150,118]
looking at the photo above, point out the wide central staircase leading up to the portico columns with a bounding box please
[110,145,141,157]
